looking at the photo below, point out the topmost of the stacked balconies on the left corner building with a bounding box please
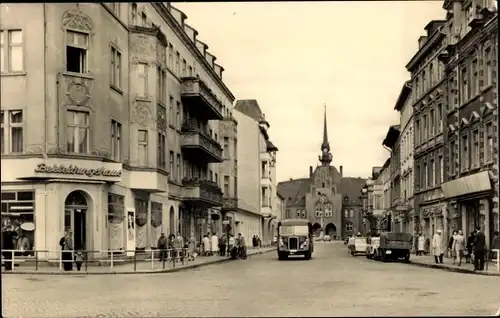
[181,77,223,120]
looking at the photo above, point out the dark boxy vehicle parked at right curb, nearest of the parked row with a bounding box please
[378,232,413,263]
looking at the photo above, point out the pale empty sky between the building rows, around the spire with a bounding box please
[174,0,445,181]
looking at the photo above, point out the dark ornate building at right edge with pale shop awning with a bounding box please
[441,0,499,244]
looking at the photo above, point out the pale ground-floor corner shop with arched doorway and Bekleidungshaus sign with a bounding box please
[1,158,172,259]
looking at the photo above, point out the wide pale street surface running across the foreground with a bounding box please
[2,242,500,317]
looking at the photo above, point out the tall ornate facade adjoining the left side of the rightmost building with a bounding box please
[406,20,448,237]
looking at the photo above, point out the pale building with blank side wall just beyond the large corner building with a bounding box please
[234,99,278,245]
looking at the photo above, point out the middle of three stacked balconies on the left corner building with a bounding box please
[181,123,223,162]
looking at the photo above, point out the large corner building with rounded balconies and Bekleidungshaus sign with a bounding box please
[0,2,234,257]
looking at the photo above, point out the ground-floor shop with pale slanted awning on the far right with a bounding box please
[441,171,498,242]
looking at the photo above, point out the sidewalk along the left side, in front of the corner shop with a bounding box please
[2,247,276,275]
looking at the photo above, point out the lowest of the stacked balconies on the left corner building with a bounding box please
[182,179,222,207]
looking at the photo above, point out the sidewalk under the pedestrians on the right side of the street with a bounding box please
[409,254,500,276]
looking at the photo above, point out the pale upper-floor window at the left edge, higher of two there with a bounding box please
[0,30,24,73]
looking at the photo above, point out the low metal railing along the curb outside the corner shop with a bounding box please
[2,248,195,271]
